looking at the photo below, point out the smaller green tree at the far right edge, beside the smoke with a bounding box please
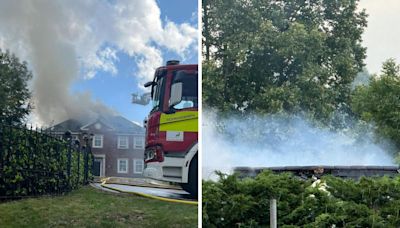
[351,59,400,148]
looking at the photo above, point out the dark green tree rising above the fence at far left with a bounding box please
[0,49,32,124]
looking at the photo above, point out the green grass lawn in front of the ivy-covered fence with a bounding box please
[0,186,197,227]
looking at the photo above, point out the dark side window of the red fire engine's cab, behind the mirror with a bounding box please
[173,70,198,109]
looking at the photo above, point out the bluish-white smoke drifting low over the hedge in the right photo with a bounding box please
[202,111,394,179]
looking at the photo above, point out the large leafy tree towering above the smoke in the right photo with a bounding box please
[203,0,367,122]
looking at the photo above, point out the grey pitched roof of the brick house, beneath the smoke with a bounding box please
[50,116,145,134]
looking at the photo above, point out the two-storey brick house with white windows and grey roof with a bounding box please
[50,116,145,177]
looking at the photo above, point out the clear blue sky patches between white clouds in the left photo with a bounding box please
[71,0,198,123]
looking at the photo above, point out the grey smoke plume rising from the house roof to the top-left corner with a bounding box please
[0,1,113,125]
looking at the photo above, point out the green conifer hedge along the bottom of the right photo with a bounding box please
[203,171,400,227]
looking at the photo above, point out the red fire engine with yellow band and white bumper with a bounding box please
[142,60,198,196]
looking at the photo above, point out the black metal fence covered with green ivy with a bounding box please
[0,124,93,200]
